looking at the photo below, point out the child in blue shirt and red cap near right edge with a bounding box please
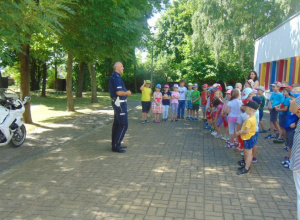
[273,86,292,143]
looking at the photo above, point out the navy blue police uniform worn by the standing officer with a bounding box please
[109,72,128,150]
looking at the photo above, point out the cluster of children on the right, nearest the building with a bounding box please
[203,82,300,175]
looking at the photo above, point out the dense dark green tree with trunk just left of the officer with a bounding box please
[61,0,167,103]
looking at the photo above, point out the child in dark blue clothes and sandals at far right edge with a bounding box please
[281,92,300,168]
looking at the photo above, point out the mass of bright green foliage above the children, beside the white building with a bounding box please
[145,0,300,87]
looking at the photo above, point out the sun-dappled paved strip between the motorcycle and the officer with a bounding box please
[0,101,139,173]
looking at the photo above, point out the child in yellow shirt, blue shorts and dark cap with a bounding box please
[236,101,259,175]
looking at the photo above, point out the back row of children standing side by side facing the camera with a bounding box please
[140,80,201,124]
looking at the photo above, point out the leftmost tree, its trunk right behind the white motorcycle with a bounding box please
[0,0,71,123]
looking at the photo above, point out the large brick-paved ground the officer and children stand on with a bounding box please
[0,103,296,220]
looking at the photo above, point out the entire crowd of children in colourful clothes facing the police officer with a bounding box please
[141,81,300,175]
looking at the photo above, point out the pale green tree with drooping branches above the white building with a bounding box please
[192,0,300,72]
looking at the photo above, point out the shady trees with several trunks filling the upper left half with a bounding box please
[0,0,168,122]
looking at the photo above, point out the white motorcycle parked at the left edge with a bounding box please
[0,89,30,147]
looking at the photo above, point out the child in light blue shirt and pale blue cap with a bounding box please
[265,82,284,139]
